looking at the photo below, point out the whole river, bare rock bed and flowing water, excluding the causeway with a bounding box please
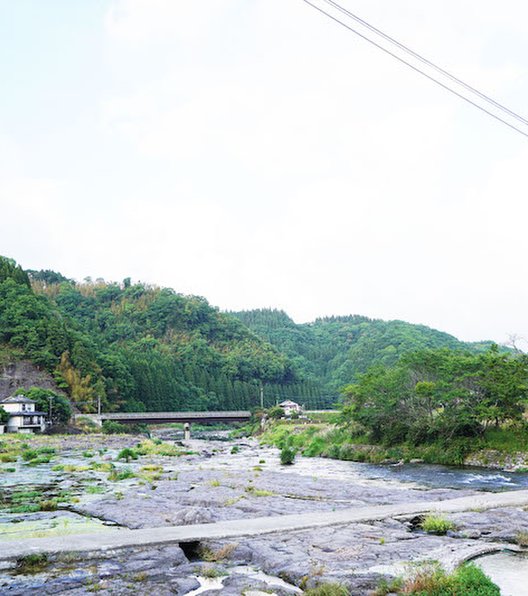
[0,431,528,596]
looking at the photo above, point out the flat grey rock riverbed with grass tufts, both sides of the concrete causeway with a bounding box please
[0,435,528,595]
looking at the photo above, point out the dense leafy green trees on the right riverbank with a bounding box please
[343,347,528,445]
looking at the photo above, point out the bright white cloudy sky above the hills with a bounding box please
[0,0,528,347]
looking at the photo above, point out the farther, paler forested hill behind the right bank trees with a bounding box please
[231,309,500,393]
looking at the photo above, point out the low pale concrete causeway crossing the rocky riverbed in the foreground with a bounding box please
[4,490,528,560]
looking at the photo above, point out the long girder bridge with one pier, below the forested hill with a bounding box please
[84,410,251,439]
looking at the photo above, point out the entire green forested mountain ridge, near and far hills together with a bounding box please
[0,257,504,411]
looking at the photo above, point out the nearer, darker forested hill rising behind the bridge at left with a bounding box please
[0,258,310,411]
